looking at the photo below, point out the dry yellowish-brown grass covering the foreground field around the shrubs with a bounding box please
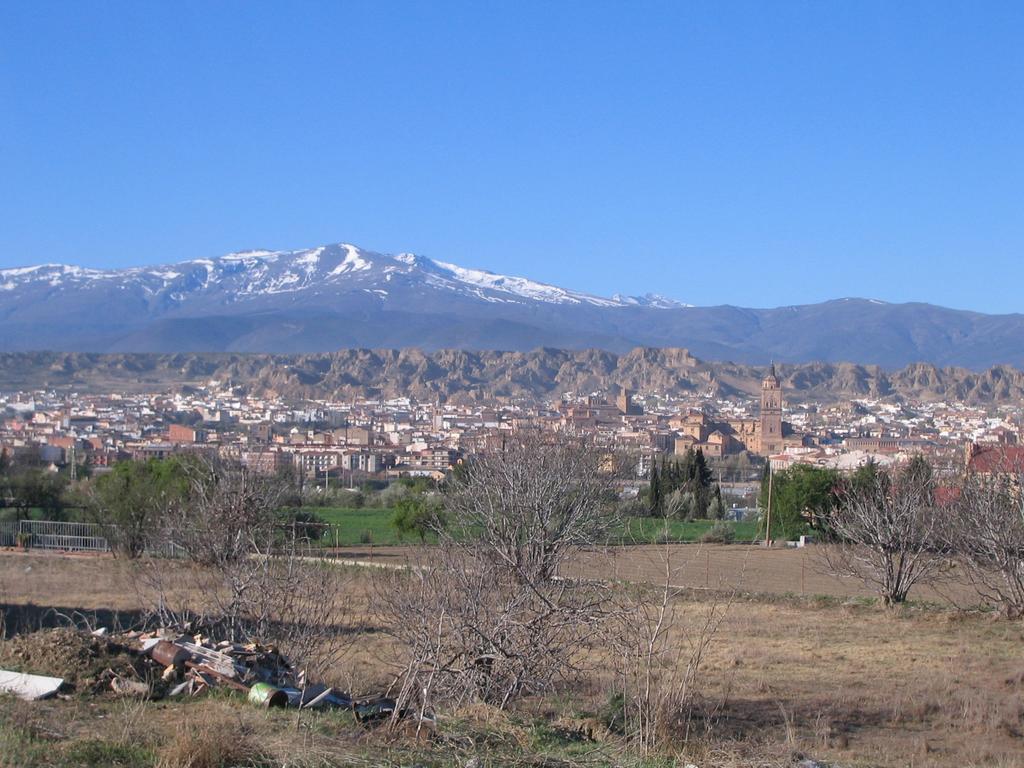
[0,555,1024,768]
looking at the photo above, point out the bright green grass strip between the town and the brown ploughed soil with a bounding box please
[303,507,758,547]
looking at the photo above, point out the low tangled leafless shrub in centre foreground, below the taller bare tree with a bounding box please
[376,545,606,709]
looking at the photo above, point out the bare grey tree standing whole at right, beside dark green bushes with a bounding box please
[823,470,944,606]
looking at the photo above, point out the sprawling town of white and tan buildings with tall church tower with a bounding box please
[0,366,1024,490]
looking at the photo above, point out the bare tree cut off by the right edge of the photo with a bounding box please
[947,473,1024,618]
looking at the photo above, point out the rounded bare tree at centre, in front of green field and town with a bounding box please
[440,431,620,584]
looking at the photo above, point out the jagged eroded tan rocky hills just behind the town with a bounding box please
[0,347,1024,403]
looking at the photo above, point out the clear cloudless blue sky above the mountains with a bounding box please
[0,0,1024,312]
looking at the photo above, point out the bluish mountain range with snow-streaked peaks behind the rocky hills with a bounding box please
[0,244,1024,370]
